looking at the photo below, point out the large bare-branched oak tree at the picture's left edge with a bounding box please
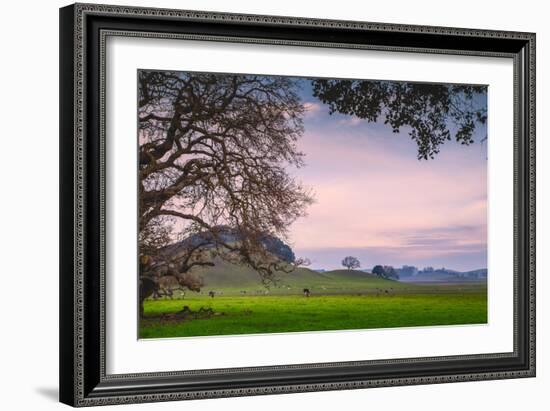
[138,70,312,316]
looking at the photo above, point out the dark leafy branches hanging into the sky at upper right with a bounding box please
[312,79,487,160]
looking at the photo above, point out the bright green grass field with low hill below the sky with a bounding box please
[140,269,487,338]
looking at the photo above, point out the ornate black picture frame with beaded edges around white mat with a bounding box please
[60,4,535,406]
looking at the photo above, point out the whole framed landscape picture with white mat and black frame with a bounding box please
[60,4,535,406]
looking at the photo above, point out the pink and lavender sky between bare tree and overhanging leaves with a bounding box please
[287,79,487,271]
